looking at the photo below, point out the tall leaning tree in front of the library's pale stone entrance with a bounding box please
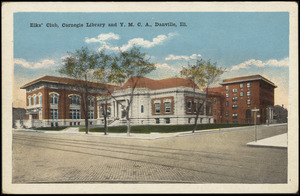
[108,46,156,135]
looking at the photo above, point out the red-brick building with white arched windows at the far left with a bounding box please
[21,76,114,127]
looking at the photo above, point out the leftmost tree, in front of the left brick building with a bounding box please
[59,48,100,134]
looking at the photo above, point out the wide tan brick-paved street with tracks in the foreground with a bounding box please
[12,125,287,183]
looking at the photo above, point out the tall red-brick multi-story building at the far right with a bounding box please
[209,75,277,124]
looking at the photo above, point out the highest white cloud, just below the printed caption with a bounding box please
[85,33,176,51]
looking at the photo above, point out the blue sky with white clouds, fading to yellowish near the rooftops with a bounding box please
[13,12,289,107]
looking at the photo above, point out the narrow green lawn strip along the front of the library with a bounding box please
[80,124,251,133]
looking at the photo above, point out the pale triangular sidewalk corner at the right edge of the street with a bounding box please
[247,133,288,148]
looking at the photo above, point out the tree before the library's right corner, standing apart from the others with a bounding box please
[181,59,226,133]
